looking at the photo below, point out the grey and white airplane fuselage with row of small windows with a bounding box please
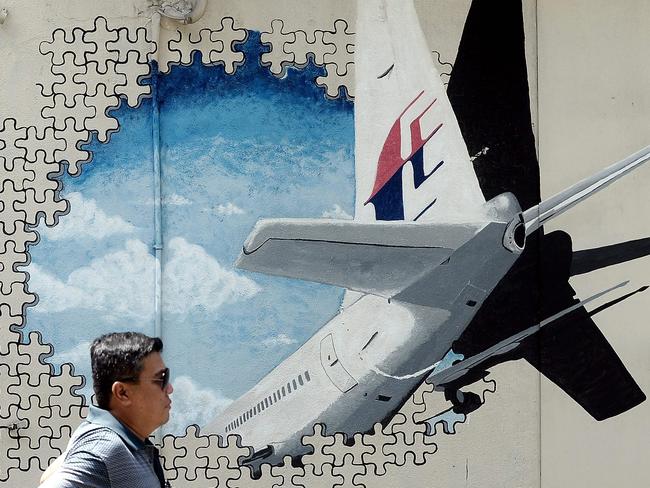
[207,214,521,464]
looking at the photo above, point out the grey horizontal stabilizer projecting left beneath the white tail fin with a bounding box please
[236,219,485,297]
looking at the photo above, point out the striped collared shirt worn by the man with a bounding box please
[41,406,169,488]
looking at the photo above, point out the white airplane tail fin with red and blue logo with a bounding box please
[355,0,485,222]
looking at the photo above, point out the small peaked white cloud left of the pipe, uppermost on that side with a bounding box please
[41,192,135,241]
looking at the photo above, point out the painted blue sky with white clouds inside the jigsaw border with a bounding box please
[28,33,354,431]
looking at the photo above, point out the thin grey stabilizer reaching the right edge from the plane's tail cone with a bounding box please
[523,146,650,235]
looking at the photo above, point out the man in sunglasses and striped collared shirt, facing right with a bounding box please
[41,332,173,488]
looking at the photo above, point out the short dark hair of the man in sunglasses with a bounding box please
[90,332,163,410]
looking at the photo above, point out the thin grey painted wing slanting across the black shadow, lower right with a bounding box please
[426,281,628,387]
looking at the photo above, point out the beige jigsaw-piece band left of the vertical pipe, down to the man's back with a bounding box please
[0,17,153,482]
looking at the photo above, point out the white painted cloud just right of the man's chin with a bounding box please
[163,376,232,434]
